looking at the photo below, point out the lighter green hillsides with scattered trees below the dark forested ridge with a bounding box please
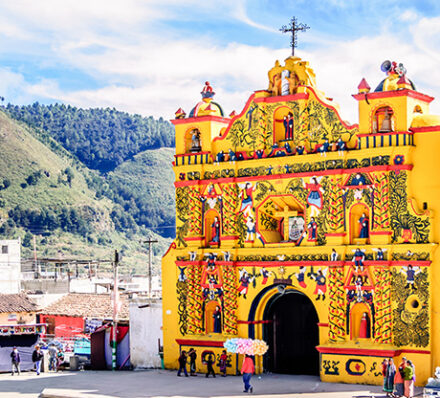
[0,107,174,266]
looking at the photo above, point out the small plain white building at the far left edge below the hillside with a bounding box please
[0,239,21,294]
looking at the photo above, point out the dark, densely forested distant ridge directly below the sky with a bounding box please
[3,102,174,172]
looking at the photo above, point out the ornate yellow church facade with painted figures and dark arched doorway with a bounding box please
[162,56,440,385]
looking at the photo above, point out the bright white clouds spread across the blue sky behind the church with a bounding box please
[0,0,440,123]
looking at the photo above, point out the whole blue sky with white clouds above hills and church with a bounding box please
[0,0,440,122]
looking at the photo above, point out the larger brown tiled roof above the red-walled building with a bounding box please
[40,293,129,320]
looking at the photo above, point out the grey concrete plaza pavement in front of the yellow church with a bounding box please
[0,369,421,398]
